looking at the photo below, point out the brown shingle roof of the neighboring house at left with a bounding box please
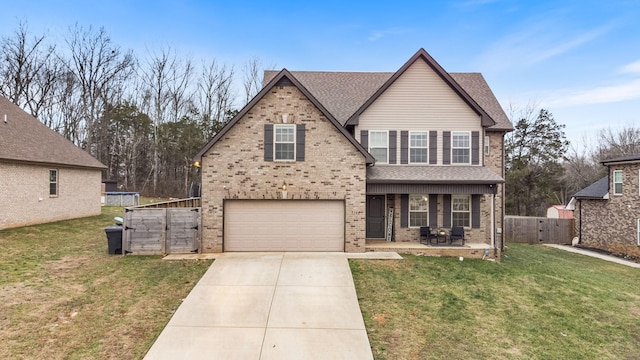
[0,96,106,169]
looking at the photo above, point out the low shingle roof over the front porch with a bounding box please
[367,165,504,184]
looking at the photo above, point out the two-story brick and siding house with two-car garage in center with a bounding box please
[195,49,513,253]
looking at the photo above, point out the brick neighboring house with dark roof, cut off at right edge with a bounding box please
[568,155,640,257]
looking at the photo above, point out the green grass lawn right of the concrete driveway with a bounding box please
[350,244,640,359]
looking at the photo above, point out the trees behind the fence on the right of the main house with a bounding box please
[505,104,640,216]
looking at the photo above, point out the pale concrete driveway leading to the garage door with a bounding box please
[145,253,373,359]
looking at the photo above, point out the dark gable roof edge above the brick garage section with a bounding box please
[194,69,375,164]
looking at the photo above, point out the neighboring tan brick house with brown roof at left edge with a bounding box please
[0,96,105,229]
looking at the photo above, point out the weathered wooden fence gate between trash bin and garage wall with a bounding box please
[122,198,201,255]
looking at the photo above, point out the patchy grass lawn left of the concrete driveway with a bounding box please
[0,207,211,359]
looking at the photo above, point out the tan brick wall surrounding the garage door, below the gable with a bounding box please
[201,86,366,252]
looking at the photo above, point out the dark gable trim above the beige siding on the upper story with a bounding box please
[346,49,496,126]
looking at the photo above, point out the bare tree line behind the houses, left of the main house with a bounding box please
[0,22,264,196]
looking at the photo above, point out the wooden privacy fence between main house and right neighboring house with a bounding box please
[504,216,575,244]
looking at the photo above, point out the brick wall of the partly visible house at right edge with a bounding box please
[574,163,640,258]
